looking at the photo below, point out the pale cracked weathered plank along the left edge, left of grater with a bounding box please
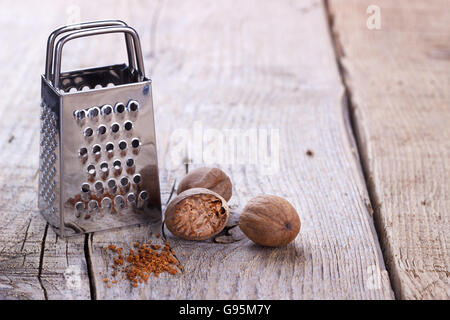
[0,2,90,299]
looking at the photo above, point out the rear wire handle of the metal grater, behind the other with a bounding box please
[45,20,136,80]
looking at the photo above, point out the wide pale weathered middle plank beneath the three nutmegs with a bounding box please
[86,0,392,299]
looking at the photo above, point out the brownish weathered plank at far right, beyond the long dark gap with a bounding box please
[330,0,450,299]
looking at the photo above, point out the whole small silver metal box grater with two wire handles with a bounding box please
[38,20,161,237]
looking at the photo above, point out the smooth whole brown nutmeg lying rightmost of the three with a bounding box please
[239,195,300,247]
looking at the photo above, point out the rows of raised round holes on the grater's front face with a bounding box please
[68,100,148,219]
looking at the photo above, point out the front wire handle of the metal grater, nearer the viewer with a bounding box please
[53,26,145,88]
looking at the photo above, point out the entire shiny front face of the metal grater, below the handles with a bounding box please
[57,82,160,235]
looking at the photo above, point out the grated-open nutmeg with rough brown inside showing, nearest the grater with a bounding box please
[165,188,230,240]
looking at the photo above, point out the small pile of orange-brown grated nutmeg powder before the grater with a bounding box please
[103,240,182,288]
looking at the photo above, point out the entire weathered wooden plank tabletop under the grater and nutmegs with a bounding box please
[0,0,450,299]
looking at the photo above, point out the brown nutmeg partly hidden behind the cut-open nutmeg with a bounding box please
[177,168,233,201]
